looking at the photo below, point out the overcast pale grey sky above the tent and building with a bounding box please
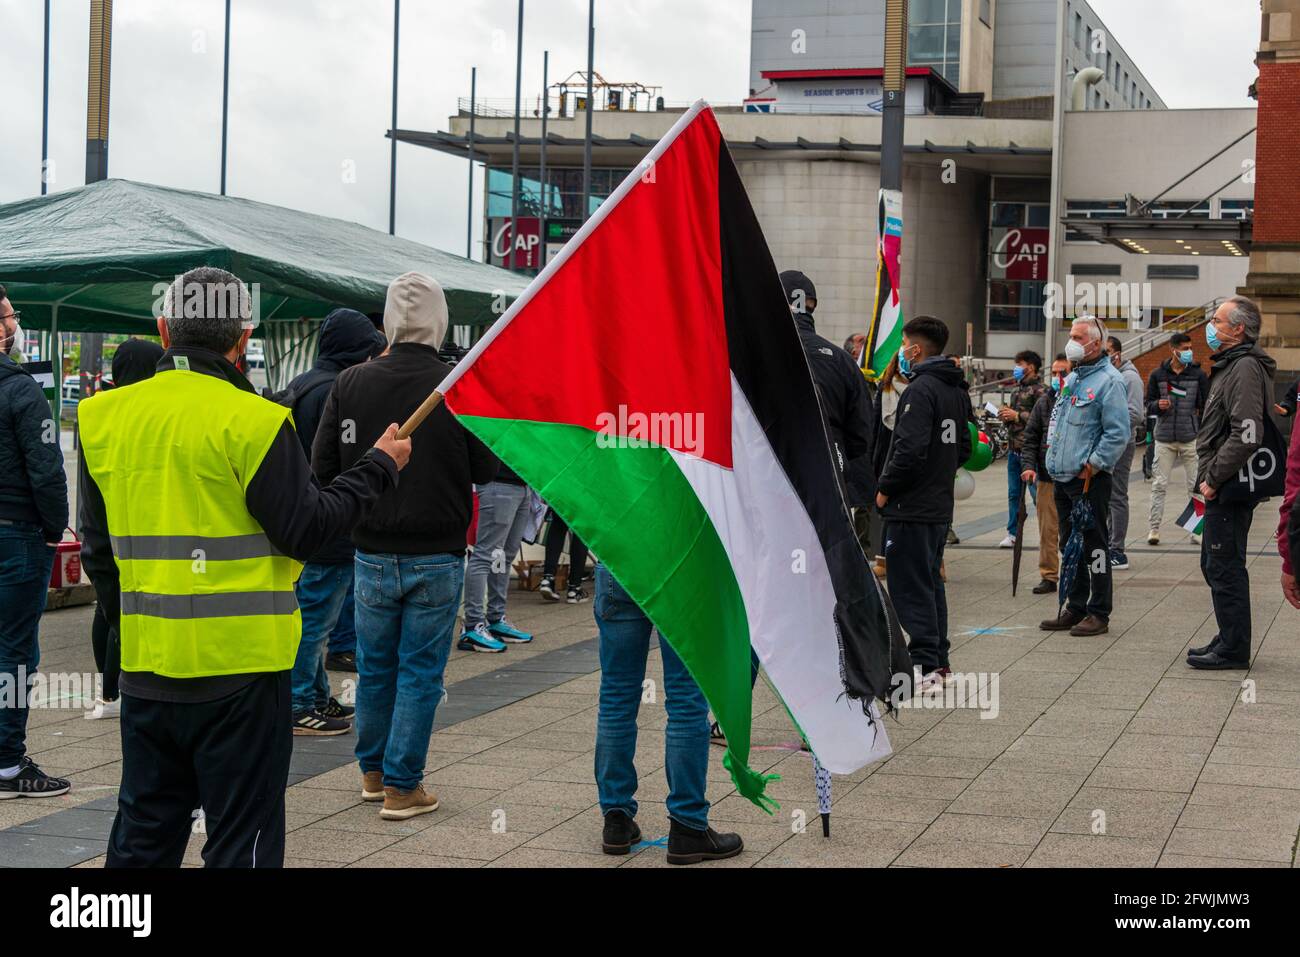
[0,0,1260,254]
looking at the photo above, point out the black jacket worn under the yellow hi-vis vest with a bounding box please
[78,348,398,703]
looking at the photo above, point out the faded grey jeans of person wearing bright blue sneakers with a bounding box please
[465,482,528,629]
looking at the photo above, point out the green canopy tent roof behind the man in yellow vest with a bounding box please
[0,179,528,385]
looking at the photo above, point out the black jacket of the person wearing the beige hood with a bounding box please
[312,342,497,555]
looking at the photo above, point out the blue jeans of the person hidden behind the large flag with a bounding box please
[595,564,709,830]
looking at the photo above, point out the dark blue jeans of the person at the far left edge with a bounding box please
[0,521,55,767]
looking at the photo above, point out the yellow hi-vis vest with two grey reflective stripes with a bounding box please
[77,369,302,677]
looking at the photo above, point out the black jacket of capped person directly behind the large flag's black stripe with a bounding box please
[793,312,875,505]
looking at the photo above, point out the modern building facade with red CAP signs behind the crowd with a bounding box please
[394,0,1256,368]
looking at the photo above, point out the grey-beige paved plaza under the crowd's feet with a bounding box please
[0,462,1300,867]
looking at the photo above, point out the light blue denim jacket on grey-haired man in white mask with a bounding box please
[1047,356,1132,482]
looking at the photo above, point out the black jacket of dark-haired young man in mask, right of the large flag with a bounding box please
[879,355,971,525]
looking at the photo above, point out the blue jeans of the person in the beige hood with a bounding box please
[356,551,465,791]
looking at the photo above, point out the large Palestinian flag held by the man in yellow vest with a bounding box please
[436,103,910,806]
